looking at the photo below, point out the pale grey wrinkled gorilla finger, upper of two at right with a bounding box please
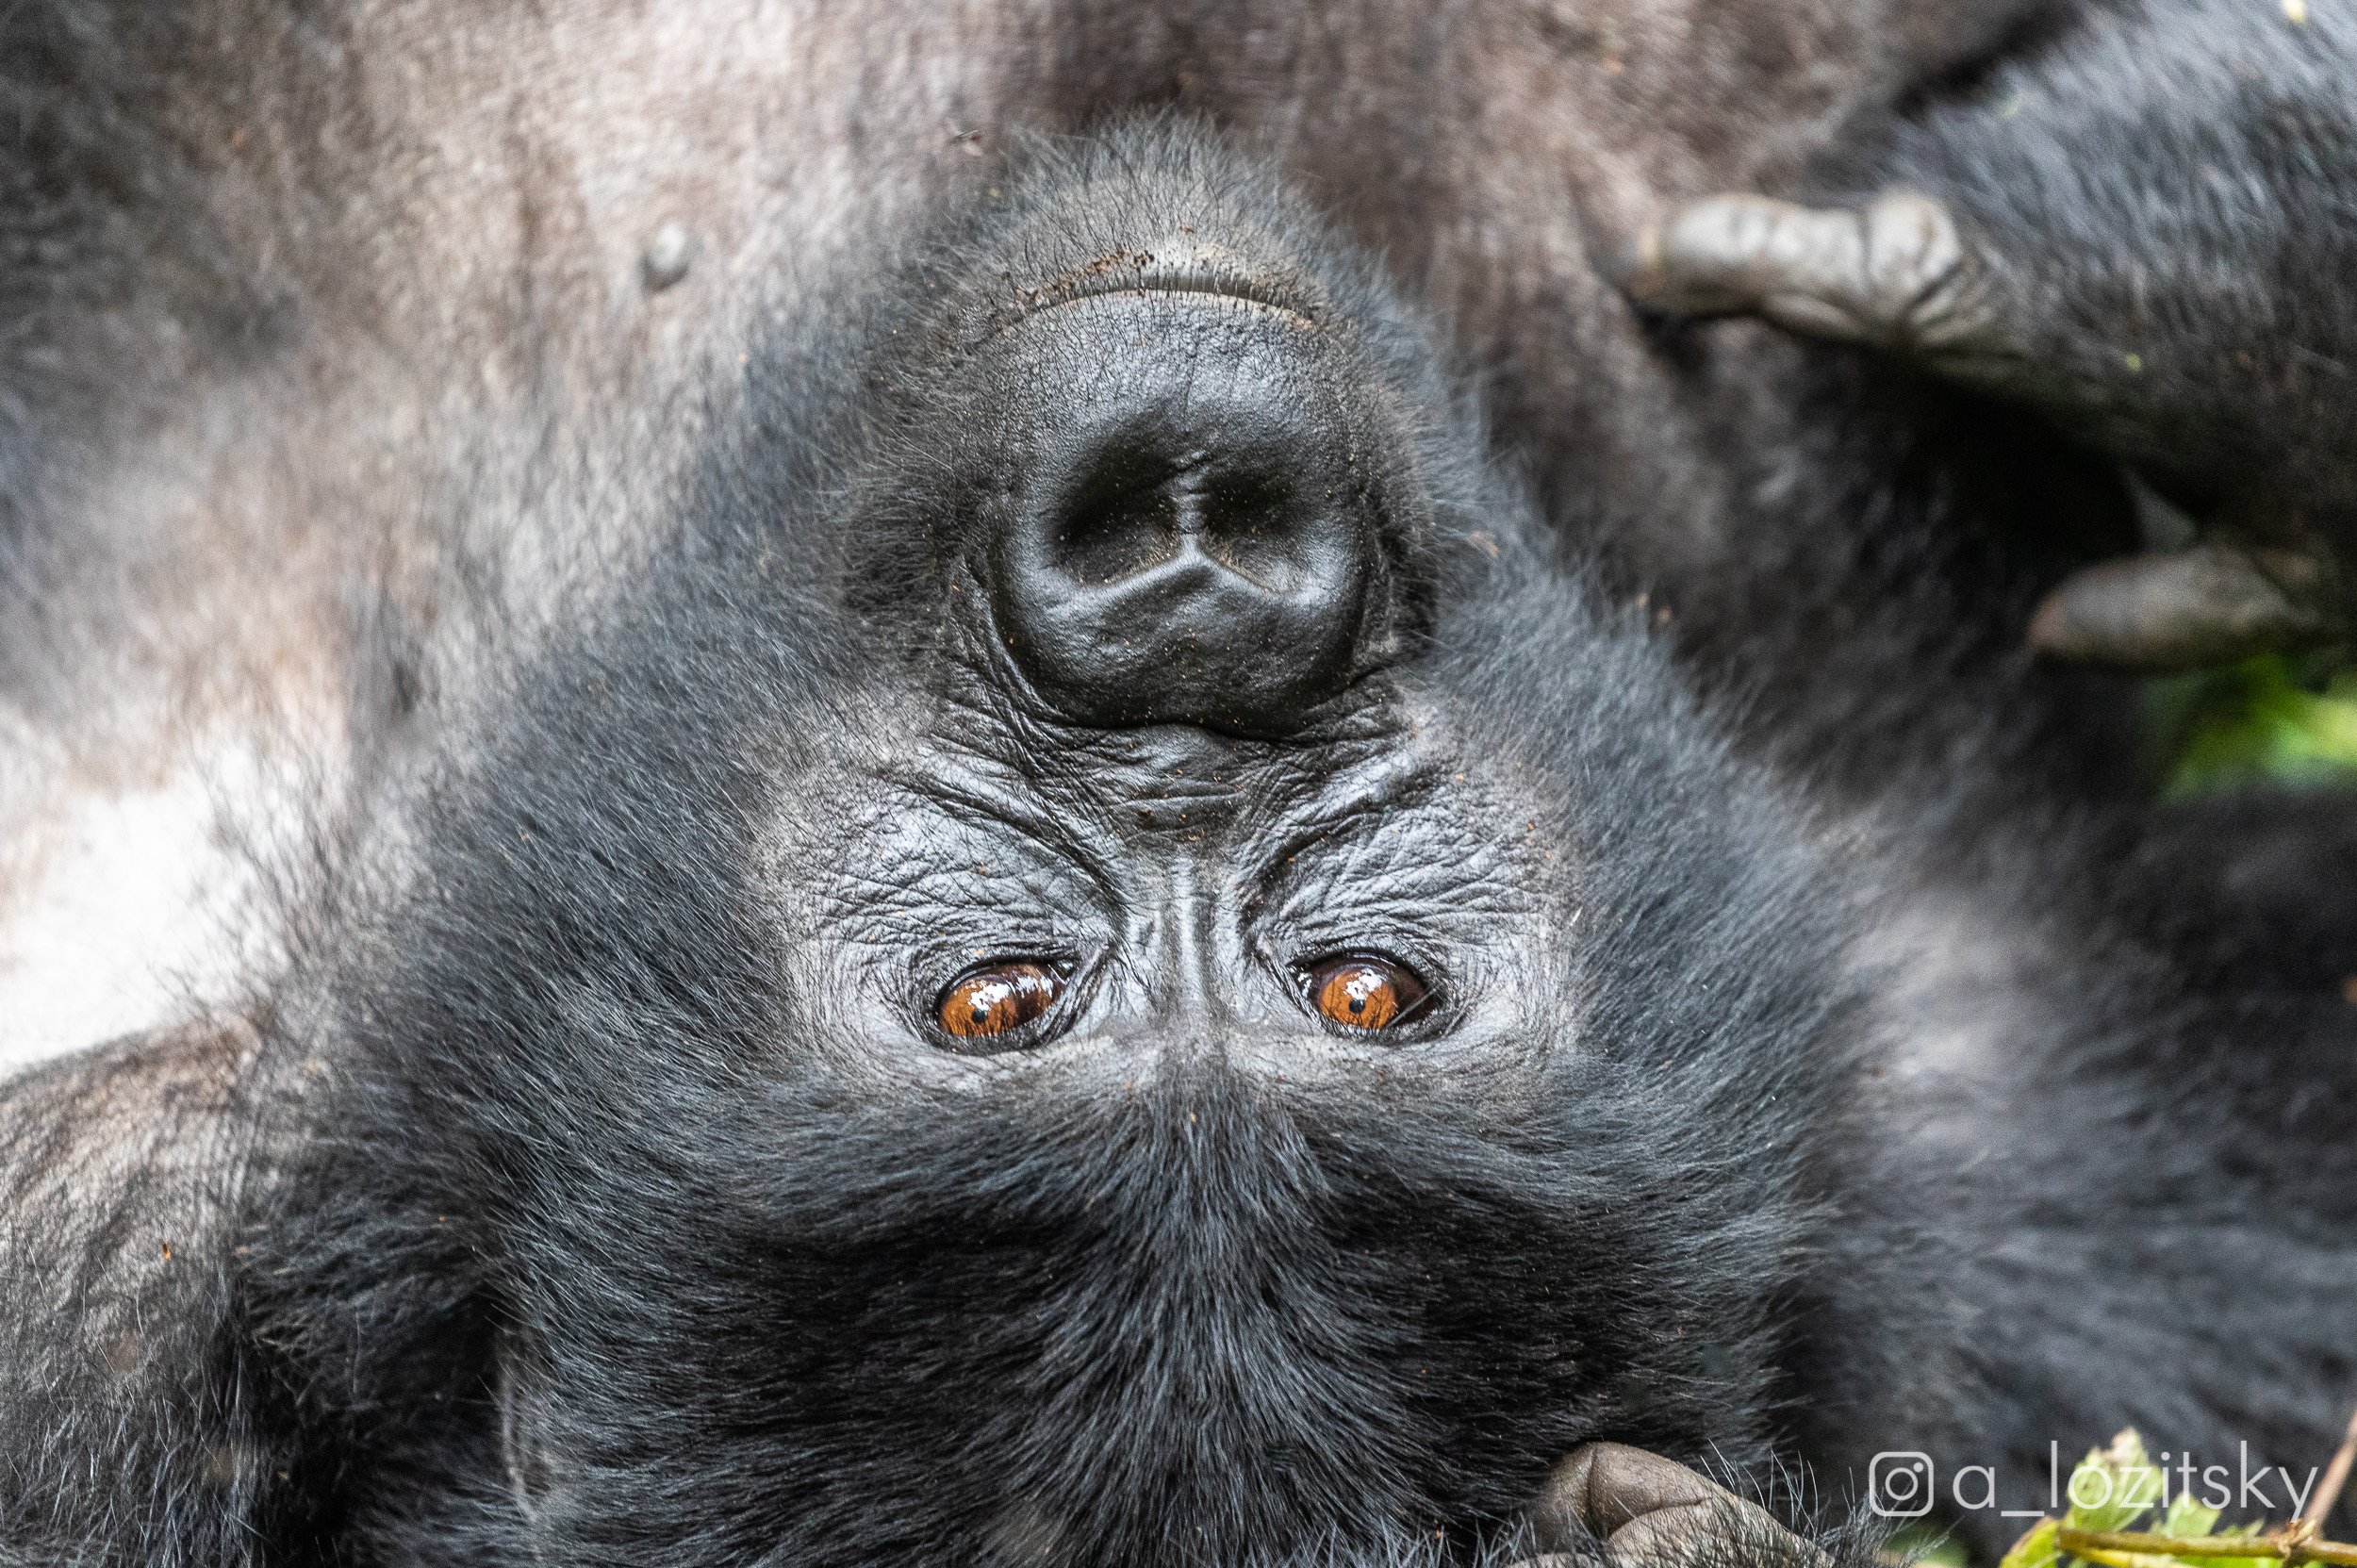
[1622,191,2002,356]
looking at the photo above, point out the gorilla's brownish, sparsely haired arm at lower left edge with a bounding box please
[0,1026,264,1568]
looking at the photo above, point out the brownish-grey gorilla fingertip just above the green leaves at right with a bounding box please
[2030,545,2332,672]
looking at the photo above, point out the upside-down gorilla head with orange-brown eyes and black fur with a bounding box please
[262,137,1838,1565]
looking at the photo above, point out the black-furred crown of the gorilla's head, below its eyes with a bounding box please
[487,1042,1744,1563]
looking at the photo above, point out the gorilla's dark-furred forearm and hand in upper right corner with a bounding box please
[1626,0,2357,668]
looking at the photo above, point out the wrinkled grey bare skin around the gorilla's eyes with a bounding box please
[776,715,1570,1084]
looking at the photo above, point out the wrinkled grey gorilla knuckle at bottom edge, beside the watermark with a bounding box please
[1530,1443,1824,1568]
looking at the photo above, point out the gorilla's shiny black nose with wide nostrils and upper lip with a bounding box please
[988,292,1386,735]
